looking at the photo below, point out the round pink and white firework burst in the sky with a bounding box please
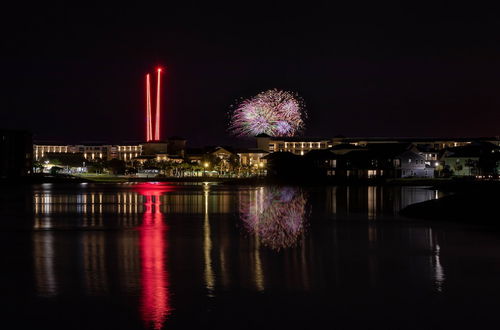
[229,89,305,136]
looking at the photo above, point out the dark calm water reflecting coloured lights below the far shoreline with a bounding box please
[0,183,500,329]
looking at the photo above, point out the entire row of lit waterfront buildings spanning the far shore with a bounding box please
[0,125,500,179]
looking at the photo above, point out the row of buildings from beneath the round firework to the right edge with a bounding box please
[256,135,500,180]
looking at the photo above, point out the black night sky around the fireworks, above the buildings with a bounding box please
[0,1,500,145]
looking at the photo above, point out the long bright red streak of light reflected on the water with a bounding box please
[136,183,173,329]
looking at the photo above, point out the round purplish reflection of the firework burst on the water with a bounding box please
[240,187,307,250]
